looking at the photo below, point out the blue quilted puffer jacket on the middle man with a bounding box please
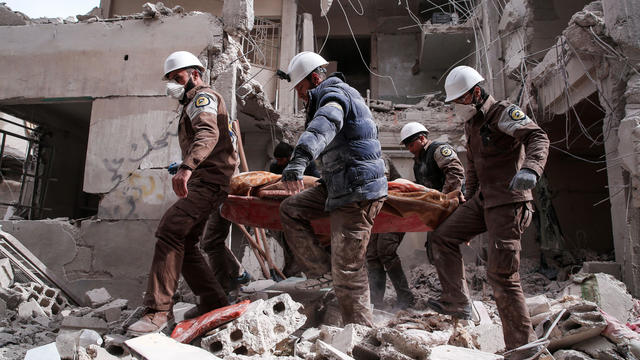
[296,73,387,211]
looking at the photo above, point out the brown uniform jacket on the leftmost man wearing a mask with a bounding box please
[178,86,238,192]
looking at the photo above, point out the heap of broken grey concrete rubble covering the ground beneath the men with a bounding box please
[0,242,640,360]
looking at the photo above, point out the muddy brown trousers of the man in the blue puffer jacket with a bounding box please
[280,185,384,326]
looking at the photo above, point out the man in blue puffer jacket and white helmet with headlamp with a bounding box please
[280,51,387,326]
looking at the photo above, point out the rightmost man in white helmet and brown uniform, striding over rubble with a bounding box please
[427,66,549,350]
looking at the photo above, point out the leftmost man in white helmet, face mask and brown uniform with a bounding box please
[128,51,238,335]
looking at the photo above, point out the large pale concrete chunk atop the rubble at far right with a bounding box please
[562,273,634,322]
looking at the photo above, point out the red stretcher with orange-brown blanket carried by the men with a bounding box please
[221,171,461,234]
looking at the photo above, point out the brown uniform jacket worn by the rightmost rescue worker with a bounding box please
[464,96,549,208]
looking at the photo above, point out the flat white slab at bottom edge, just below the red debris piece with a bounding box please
[125,334,220,360]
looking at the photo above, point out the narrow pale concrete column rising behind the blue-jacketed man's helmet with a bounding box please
[278,0,298,114]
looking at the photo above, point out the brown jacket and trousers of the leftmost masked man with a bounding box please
[144,86,238,311]
